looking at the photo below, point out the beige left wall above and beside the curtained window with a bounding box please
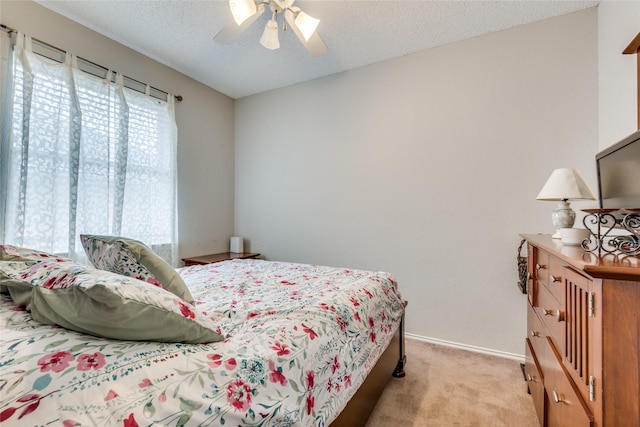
[0,1,234,257]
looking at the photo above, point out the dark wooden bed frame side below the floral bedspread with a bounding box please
[329,310,407,427]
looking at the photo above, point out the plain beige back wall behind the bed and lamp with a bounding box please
[235,9,598,355]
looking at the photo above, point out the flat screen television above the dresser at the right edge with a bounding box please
[596,131,640,218]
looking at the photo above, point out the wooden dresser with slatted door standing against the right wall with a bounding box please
[522,235,640,427]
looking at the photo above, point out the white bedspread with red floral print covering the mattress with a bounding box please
[0,260,404,427]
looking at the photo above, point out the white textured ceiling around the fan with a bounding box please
[36,0,599,98]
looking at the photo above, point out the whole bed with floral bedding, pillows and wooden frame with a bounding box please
[0,241,405,426]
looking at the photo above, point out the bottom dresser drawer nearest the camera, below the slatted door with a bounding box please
[544,342,594,427]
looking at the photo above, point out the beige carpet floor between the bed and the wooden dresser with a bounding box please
[366,339,539,427]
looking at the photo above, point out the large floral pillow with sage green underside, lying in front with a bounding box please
[3,260,223,343]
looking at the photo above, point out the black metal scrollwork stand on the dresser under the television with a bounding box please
[581,208,640,255]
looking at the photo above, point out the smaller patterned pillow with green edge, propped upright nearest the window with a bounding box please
[80,234,194,303]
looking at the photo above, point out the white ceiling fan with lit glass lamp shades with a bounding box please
[214,0,327,56]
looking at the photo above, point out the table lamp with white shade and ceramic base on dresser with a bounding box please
[536,168,595,239]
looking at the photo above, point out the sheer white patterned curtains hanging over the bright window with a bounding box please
[0,34,178,266]
